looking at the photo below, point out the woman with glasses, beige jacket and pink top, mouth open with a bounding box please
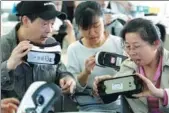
[94,18,169,113]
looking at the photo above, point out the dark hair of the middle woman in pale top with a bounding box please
[75,1,103,30]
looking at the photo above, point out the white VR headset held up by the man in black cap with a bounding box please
[24,39,61,65]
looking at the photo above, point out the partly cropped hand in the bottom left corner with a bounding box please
[1,98,19,113]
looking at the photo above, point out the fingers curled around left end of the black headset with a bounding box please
[93,75,113,95]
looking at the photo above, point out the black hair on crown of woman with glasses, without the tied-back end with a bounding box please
[121,18,161,45]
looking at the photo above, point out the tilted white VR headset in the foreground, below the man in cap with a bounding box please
[17,81,61,113]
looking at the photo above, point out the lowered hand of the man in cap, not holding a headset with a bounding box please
[60,76,76,94]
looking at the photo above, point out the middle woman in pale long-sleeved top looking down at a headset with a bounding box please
[67,1,123,112]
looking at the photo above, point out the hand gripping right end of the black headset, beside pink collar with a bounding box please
[133,73,164,98]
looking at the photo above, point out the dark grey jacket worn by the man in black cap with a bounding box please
[0,24,71,99]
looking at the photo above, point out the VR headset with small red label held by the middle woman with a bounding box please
[95,51,128,70]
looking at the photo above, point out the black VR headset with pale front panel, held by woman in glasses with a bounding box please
[98,75,143,103]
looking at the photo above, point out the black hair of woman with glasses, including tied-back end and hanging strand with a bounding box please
[121,18,166,57]
